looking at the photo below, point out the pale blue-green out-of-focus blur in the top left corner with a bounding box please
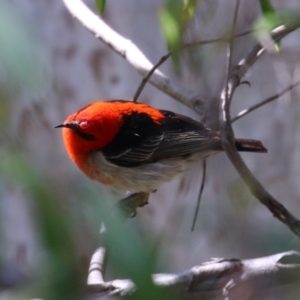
[0,1,40,92]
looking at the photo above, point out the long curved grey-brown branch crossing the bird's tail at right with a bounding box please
[220,19,300,237]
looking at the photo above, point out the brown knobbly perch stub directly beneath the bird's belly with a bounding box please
[117,192,149,219]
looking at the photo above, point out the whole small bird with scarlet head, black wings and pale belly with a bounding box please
[55,100,268,193]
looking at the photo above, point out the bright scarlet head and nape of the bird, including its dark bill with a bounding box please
[56,100,163,172]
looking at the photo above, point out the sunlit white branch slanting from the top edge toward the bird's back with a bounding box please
[63,0,205,114]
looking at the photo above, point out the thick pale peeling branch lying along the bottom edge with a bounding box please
[85,251,300,300]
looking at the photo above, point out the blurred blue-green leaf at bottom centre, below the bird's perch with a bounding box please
[100,202,169,300]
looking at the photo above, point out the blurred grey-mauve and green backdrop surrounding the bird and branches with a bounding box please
[0,0,300,300]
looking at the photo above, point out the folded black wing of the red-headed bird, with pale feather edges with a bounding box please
[102,110,220,167]
